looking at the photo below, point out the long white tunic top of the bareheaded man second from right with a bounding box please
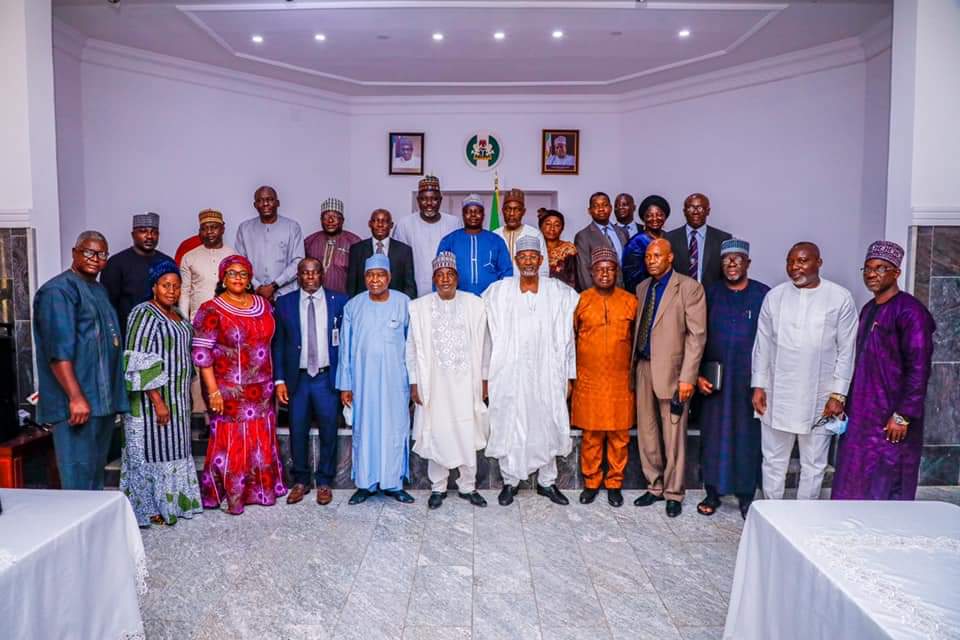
[750,279,858,434]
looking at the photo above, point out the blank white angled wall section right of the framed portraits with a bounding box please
[622,64,883,294]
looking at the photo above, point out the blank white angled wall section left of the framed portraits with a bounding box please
[75,55,349,256]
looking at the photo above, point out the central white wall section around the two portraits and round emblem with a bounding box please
[347,98,622,239]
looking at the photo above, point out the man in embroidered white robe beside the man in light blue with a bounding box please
[407,251,489,509]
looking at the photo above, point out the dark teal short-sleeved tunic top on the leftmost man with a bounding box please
[33,271,130,422]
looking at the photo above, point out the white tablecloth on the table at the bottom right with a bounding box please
[723,500,960,640]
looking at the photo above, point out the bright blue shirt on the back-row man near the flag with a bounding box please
[437,229,513,296]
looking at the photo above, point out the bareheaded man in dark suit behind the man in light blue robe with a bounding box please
[347,209,417,300]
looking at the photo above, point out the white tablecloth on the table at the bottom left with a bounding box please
[0,489,146,640]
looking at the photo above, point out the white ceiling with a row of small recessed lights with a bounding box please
[54,0,891,95]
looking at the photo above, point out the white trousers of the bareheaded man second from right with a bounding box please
[760,426,831,500]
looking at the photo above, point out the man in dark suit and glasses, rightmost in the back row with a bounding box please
[666,193,732,289]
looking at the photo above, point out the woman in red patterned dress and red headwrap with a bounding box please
[193,255,287,515]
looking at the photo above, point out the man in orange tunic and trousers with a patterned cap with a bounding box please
[571,247,637,507]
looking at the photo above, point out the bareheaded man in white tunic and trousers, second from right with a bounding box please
[751,242,858,500]
